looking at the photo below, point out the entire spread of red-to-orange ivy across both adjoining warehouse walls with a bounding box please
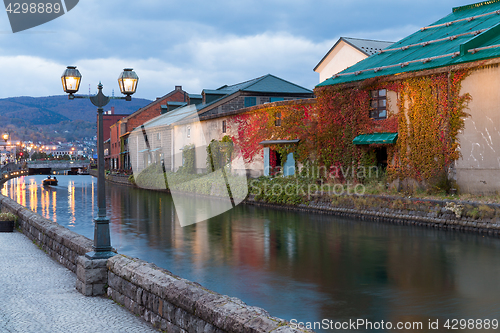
[231,71,471,186]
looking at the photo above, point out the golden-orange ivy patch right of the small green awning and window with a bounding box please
[390,71,471,184]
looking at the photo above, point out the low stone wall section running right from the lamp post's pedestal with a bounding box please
[107,255,304,333]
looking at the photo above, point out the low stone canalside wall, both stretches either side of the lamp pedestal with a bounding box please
[0,171,310,333]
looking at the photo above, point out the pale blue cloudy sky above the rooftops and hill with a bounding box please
[0,0,471,99]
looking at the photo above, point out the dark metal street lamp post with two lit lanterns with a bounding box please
[61,66,139,259]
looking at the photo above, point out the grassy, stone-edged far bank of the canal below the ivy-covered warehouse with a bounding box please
[99,171,500,236]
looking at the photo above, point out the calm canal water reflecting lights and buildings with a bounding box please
[1,176,500,332]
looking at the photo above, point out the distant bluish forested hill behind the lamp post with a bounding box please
[0,95,151,141]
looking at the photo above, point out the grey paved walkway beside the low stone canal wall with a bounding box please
[0,232,158,333]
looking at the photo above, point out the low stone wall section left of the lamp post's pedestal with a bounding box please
[0,196,93,273]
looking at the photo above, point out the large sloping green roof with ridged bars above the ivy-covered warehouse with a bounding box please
[317,0,500,87]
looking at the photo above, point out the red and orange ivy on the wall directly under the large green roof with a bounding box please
[316,71,471,186]
